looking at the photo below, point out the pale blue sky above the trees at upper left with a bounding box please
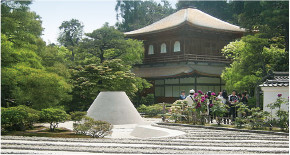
[30,0,175,44]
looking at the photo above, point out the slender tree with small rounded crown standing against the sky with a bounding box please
[57,19,84,61]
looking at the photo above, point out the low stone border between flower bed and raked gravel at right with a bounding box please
[156,123,289,136]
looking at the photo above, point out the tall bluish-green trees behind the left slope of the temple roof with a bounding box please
[115,0,174,32]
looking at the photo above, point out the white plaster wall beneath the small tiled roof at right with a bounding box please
[261,87,289,115]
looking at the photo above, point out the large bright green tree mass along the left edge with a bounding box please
[1,1,71,109]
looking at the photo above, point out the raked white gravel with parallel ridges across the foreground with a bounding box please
[1,125,289,154]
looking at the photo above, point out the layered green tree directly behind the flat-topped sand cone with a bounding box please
[70,59,150,111]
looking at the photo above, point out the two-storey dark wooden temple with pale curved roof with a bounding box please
[125,8,245,102]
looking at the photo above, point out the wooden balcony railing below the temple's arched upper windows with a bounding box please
[144,54,231,64]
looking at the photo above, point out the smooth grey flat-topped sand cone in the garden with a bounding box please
[87,91,144,125]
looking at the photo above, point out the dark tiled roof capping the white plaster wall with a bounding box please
[260,72,289,87]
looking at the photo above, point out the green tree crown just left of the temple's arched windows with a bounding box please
[76,23,144,65]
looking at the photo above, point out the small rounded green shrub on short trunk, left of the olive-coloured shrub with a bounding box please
[40,108,70,131]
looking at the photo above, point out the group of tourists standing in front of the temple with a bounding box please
[180,89,249,124]
